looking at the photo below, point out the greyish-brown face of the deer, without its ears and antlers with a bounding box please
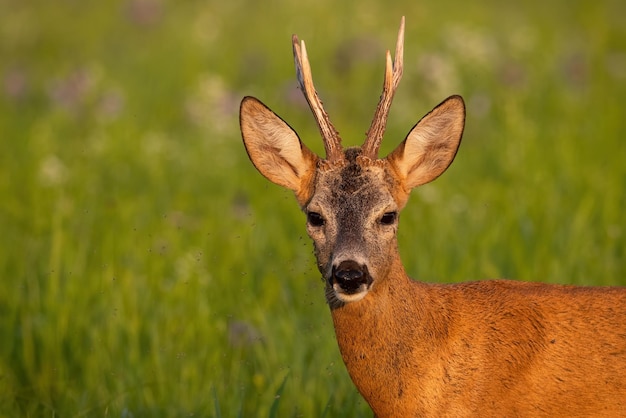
[304,148,398,305]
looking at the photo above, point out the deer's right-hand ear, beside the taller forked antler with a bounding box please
[386,96,465,191]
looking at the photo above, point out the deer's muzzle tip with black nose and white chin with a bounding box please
[328,260,373,302]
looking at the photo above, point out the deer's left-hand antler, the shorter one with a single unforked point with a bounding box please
[292,35,343,161]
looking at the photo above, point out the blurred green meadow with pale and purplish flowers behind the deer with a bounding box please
[0,0,626,417]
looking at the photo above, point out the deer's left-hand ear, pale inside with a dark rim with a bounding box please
[239,97,318,196]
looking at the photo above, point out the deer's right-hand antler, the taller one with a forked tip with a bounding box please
[362,16,404,159]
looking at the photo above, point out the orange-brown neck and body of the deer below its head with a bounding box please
[332,277,626,417]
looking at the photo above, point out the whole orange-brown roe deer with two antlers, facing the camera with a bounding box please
[240,17,626,418]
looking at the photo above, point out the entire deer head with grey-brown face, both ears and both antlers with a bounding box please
[240,18,465,307]
